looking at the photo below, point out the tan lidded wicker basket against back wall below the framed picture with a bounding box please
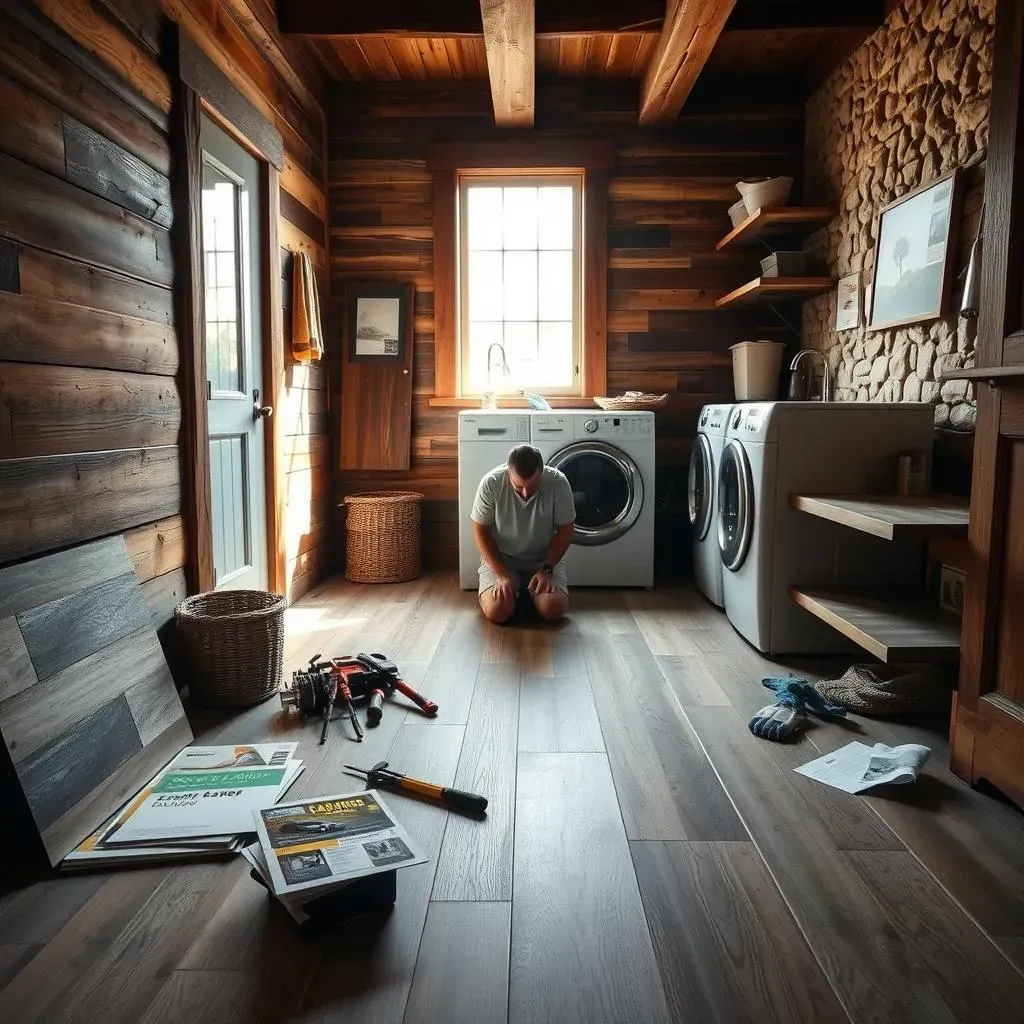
[345,490,423,583]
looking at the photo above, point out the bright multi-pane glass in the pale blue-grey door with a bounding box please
[203,161,243,391]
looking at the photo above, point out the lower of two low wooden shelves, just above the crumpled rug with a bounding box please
[790,587,961,662]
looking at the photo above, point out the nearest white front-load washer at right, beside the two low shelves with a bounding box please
[718,401,934,654]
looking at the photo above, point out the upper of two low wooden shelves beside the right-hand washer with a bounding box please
[790,495,971,541]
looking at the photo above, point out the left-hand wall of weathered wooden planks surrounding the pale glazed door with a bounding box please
[0,0,330,643]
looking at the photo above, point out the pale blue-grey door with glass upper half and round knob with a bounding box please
[201,118,272,590]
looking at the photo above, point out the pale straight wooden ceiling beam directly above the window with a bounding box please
[479,0,537,128]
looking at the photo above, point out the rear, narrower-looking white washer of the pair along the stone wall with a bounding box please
[687,406,732,608]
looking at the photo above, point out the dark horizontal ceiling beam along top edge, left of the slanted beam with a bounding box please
[278,0,665,39]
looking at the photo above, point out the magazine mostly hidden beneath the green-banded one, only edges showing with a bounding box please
[60,759,304,870]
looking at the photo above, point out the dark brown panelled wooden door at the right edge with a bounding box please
[950,3,1024,805]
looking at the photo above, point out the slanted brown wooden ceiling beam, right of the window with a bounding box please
[640,0,736,125]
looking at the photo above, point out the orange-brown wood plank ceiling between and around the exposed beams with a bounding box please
[278,0,888,99]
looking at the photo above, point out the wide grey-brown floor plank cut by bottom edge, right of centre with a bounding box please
[630,842,846,1024]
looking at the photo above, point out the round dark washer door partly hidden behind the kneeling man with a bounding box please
[548,441,643,547]
